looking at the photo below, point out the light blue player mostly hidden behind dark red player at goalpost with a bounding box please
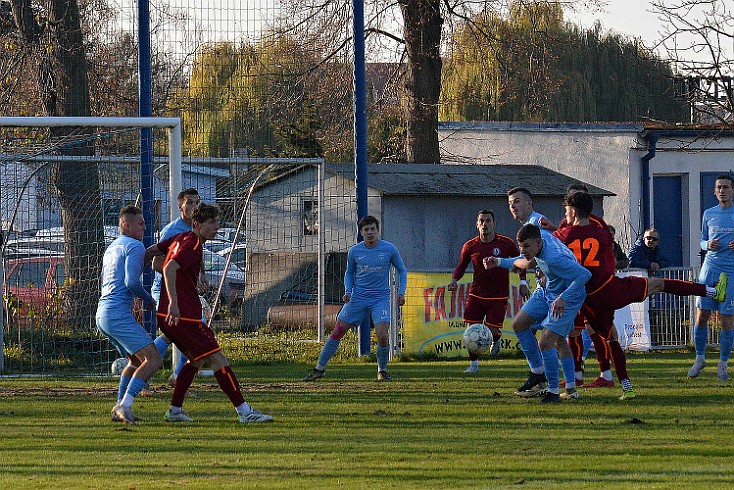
[150,187,201,386]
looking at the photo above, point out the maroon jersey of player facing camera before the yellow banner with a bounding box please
[451,234,520,300]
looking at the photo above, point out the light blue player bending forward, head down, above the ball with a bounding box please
[484,224,591,403]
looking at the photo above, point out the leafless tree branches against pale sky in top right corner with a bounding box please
[652,0,734,126]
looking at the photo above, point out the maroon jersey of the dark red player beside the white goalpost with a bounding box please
[158,231,204,323]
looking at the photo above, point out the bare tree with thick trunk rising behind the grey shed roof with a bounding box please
[283,0,604,163]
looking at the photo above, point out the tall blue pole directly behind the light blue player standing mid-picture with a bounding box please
[352,0,370,356]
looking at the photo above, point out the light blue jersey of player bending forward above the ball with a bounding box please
[500,230,591,303]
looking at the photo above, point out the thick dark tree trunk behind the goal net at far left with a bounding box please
[3,0,104,325]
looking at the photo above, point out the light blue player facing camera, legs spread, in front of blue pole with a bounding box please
[303,216,408,381]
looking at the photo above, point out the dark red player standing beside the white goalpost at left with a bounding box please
[149,204,273,423]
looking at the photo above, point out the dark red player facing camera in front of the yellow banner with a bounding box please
[448,209,529,373]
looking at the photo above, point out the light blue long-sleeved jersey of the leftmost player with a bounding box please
[98,235,154,314]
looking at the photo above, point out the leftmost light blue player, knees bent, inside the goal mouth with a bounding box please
[96,206,163,425]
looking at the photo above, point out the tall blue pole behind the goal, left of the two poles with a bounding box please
[138,0,156,335]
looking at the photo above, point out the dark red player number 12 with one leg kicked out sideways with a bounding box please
[554,192,726,400]
